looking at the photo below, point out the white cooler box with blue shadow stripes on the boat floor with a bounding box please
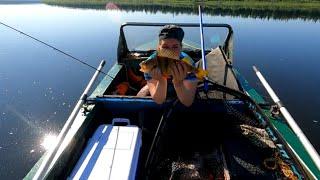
[68,119,142,180]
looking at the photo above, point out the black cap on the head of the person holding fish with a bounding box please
[159,25,184,42]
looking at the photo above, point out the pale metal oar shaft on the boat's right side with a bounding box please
[253,66,320,170]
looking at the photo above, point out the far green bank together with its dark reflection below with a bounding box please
[41,0,320,21]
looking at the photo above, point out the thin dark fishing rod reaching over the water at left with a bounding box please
[0,21,114,79]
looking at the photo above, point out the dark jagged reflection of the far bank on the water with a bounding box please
[45,3,320,22]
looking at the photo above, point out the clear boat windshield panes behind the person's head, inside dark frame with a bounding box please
[123,25,229,52]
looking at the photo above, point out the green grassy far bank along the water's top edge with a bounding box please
[41,0,320,11]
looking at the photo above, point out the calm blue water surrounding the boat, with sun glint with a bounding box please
[0,4,320,179]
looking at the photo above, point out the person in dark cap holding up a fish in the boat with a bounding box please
[137,25,198,106]
